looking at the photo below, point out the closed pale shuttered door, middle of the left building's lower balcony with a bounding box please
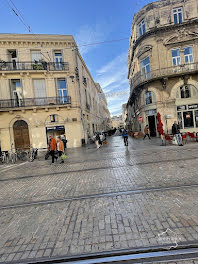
[33,79,47,105]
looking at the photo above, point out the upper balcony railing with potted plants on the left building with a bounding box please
[0,61,69,71]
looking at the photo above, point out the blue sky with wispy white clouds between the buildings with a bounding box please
[0,0,151,115]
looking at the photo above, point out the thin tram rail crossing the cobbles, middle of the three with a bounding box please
[0,179,198,210]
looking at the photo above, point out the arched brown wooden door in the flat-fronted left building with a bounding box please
[13,120,30,149]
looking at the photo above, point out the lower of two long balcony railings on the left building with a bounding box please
[0,96,71,109]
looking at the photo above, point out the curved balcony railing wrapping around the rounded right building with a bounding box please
[132,63,198,88]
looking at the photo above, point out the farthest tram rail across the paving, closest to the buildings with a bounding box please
[0,157,198,183]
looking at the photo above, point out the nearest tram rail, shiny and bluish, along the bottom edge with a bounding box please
[5,244,198,264]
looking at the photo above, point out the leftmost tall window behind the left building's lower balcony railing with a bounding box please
[10,79,23,106]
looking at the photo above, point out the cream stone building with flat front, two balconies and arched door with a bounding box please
[0,34,110,150]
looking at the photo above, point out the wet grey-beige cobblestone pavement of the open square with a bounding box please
[0,136,198,264]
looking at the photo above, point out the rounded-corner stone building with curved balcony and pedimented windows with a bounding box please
[127,0,198,136]
